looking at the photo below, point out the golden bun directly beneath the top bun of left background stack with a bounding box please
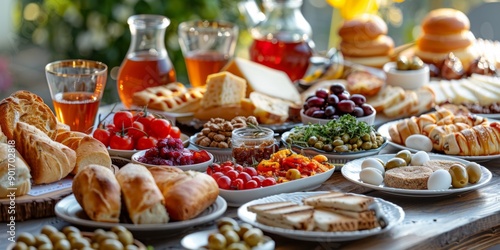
[340,35,394,57]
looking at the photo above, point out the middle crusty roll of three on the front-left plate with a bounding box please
[116,163,169,224]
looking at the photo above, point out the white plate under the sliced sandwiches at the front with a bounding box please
[238,192,405,242]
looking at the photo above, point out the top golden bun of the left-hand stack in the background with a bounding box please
[338,14,387,42]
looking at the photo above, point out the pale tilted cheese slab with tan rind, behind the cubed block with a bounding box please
[222,57,301,103]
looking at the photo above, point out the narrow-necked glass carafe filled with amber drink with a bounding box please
[117,15,176,108]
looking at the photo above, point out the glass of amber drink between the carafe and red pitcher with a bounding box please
[178,20,238,87]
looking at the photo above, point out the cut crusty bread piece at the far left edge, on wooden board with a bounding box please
[0,143,31,198]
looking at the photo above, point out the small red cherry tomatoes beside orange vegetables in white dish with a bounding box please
[207,161,276,190]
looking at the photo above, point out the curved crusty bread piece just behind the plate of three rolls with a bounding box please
[55,131,112,174]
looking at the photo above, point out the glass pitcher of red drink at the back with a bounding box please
[245,0,314,81]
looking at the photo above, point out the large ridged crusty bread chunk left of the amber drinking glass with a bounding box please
[14,122,76,184]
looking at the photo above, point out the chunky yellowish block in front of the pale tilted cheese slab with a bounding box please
[201,72,247,108]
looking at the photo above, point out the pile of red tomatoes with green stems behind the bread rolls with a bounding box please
[93,111,181,150]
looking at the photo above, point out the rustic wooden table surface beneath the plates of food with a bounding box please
[0,147,500,249]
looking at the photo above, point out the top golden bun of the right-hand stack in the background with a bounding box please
[422,8,470,35]
